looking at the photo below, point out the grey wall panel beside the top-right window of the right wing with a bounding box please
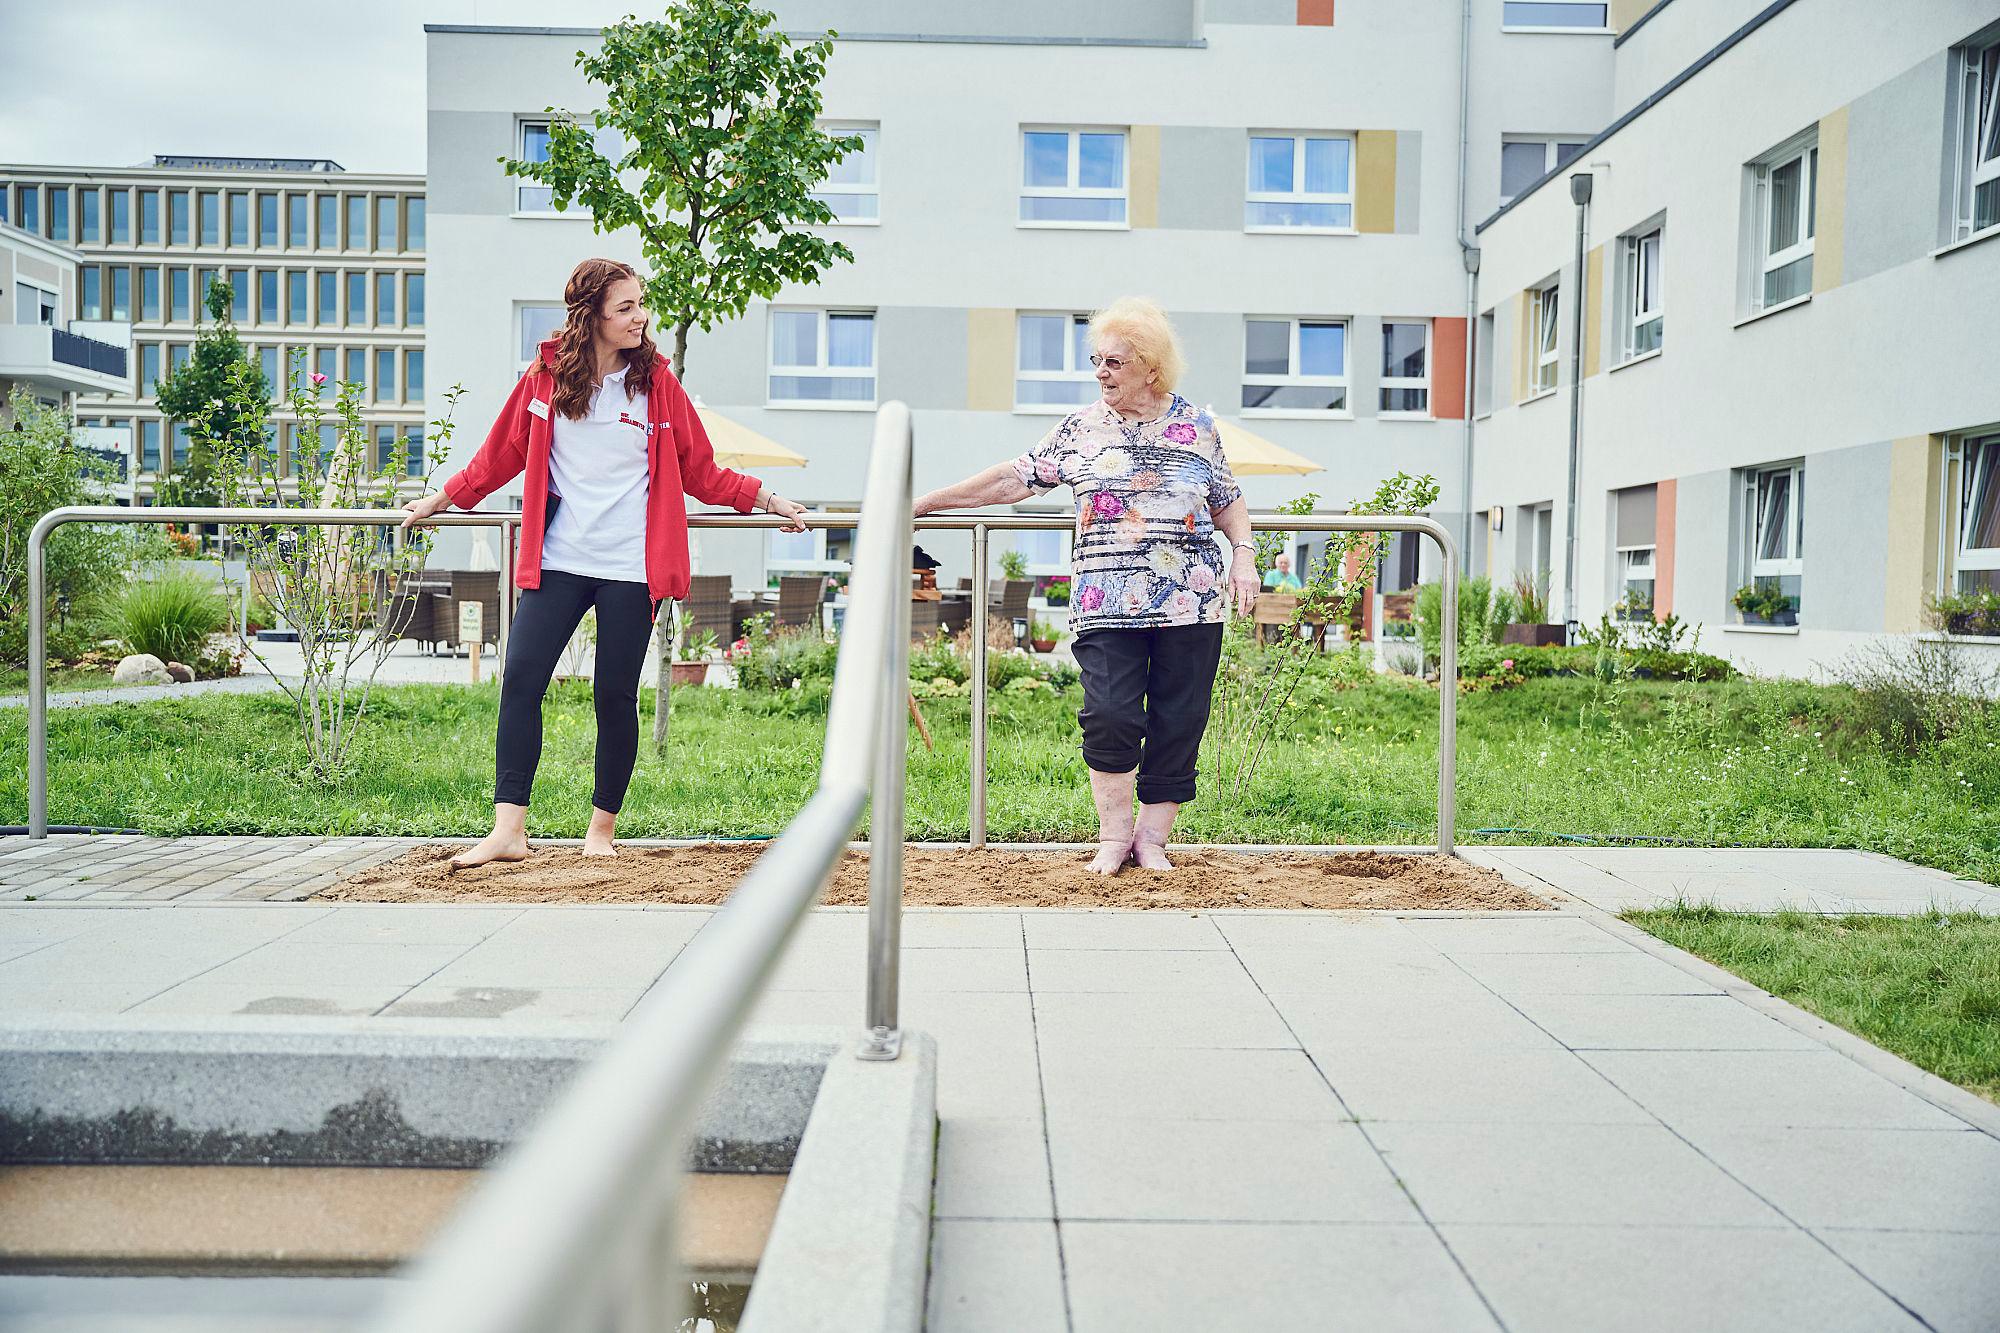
[1842,52,1946,282]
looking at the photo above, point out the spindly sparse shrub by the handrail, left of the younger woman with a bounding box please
[190,352,462,781]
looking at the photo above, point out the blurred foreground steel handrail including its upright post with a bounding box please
[362,402,910,1333]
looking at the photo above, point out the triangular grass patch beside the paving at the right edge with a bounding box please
[1626,907,2000,1101]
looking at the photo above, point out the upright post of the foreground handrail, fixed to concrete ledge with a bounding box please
[858,416,912,1061]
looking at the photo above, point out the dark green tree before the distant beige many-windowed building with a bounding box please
[154,278,272,506]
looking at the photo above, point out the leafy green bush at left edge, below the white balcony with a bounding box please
[0,388,136,664]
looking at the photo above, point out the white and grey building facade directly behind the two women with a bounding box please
[426,0,1640,582]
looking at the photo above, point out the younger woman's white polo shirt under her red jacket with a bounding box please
[542,370,646,582]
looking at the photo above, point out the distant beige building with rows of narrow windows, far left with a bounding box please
[0,156,428,502]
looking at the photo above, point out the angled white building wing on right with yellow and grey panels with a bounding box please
[1470,0,2000,675]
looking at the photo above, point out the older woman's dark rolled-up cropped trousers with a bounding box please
[1074,624,1222,805]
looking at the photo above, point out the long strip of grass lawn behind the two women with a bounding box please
[0,677,2000,881]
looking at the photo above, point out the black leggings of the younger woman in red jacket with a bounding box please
[494,568,654,815]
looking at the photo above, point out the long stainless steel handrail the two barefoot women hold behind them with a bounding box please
[28,506,1460,844]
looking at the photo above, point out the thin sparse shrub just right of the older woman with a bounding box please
[1206,472,1438,797]
